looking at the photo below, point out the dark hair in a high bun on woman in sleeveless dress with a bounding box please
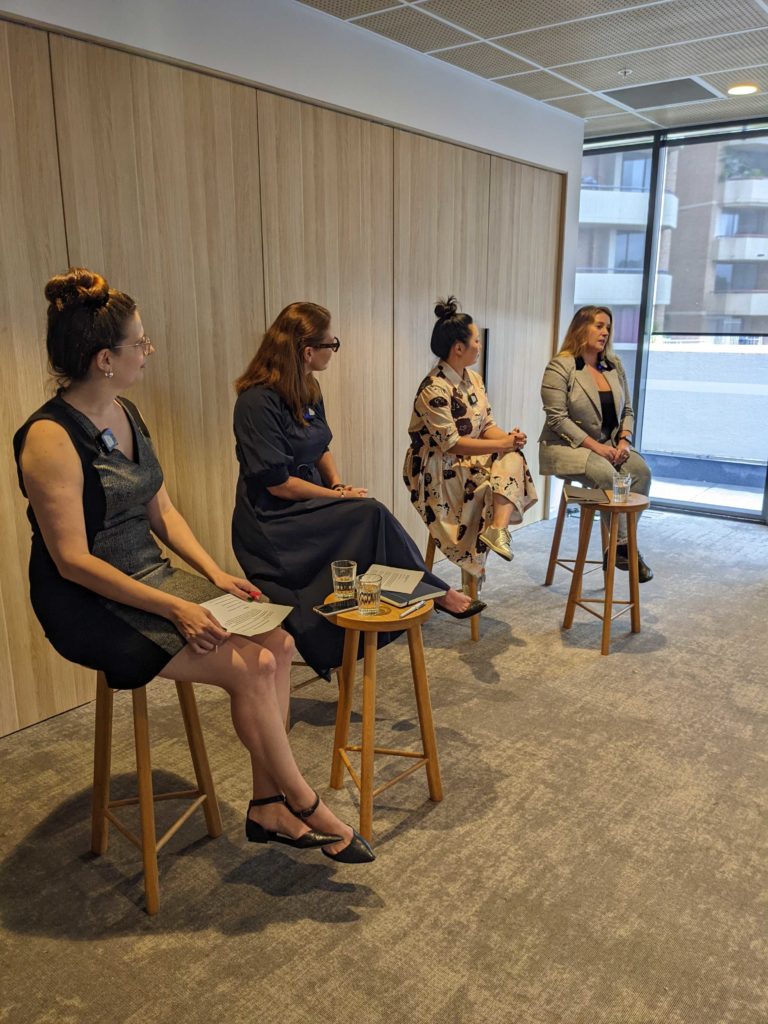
[45,266,136,387]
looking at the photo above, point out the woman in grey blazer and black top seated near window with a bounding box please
[539,306,653,583]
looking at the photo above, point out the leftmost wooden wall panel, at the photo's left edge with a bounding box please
[0,22,93,735]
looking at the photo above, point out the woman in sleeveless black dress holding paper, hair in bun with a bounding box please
[13,268,374,862]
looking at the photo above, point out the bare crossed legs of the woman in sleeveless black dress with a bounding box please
[163,630,352,853]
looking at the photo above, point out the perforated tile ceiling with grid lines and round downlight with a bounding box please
[292,0,768,137]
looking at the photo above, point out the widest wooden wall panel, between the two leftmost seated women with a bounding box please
[51,36,264,569]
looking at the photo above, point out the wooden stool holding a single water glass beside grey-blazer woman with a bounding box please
[562,492,650,654]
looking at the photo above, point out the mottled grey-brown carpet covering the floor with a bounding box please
[0,513,768,1024]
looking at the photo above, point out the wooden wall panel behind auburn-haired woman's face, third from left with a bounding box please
[259,92,393,507]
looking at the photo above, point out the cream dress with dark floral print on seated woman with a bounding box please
[402,360,538,575]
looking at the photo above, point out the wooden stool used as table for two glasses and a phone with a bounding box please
[327,595,442,841]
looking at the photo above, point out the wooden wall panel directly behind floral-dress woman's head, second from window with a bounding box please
[393,131,490,551]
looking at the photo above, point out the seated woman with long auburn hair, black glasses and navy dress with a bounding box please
[232,302,484,675]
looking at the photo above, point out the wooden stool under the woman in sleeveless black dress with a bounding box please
[91,672,221,913]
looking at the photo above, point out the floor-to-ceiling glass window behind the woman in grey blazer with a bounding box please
[577,128,768,518]
